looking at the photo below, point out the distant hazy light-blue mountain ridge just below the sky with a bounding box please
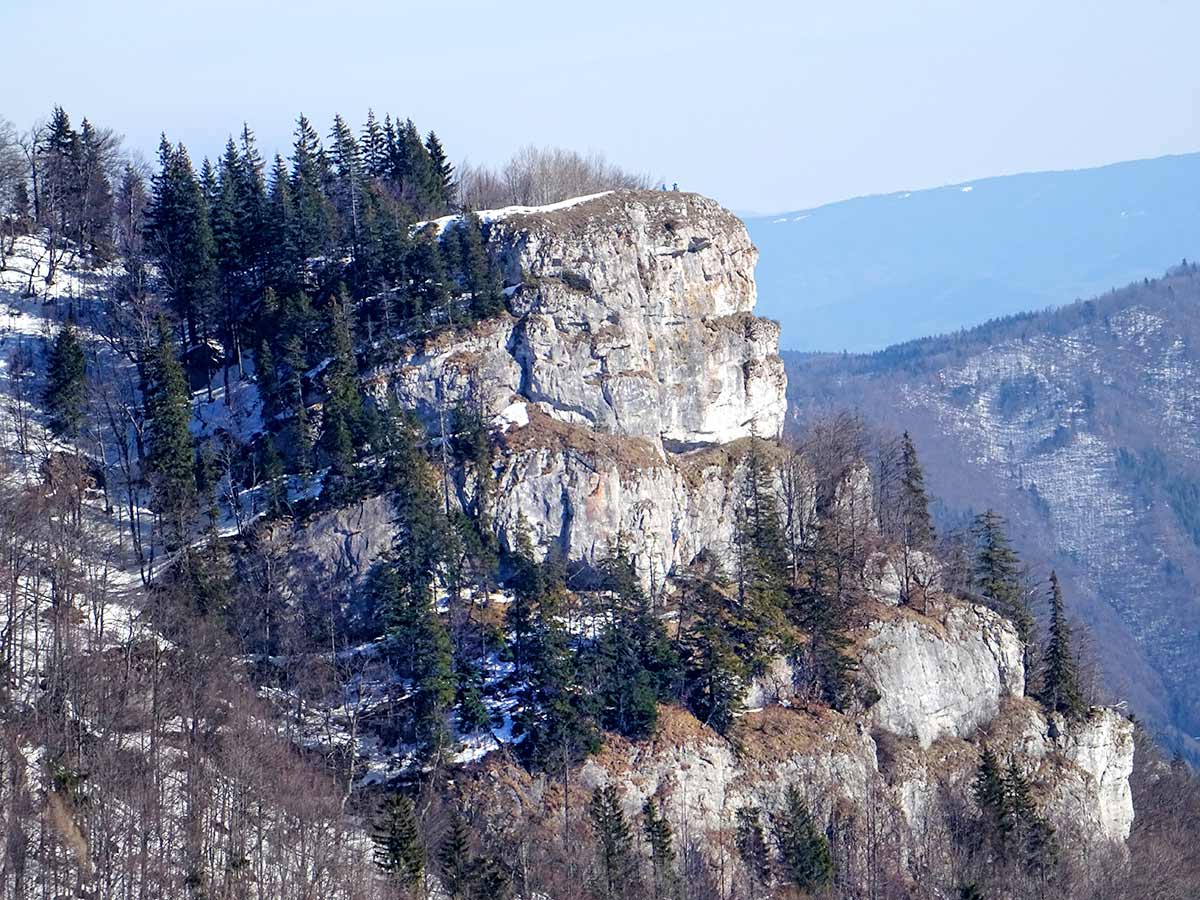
[745,154,1200,352]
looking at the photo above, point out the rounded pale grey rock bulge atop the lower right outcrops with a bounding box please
[862,604,1025,746]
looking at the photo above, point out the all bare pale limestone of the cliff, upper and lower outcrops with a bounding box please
[267,192,1133,878]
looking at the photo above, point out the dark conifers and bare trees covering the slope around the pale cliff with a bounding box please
[0,108,1200,900]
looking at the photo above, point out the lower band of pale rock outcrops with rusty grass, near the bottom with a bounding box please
[463,599,1134,884]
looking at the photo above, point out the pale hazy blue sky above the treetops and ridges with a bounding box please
[0,0,1200,211]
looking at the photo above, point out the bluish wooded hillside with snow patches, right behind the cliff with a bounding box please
[787,266,1200,755]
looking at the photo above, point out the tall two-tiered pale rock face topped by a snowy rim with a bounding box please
[371,191,786,588]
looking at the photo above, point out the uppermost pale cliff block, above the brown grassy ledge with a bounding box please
[372,191,786,449]
